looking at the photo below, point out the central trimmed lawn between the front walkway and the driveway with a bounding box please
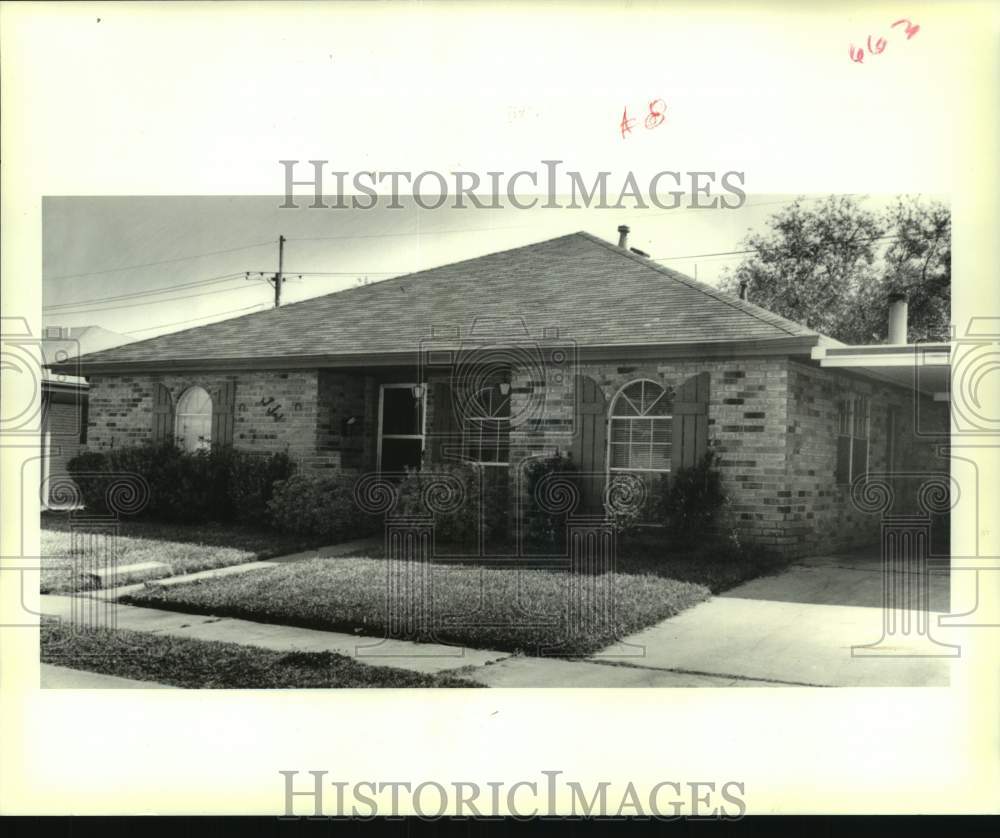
[122,558,711,656]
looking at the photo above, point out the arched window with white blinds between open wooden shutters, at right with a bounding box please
[608,379,673,472]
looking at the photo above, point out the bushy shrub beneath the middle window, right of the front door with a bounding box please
[394,463,500,547]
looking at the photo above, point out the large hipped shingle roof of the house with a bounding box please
[58,232,821,373]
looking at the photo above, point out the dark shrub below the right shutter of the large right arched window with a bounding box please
[654,451,727,548]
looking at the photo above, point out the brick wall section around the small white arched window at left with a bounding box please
[87,370,319,459]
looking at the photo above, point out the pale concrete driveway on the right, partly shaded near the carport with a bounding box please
[596,553,955,687]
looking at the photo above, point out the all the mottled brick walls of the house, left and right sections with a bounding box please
[82,358,948,554]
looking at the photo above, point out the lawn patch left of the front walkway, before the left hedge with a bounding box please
[41,513,328,593]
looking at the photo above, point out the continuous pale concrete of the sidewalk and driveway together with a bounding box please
[41,556,953,687]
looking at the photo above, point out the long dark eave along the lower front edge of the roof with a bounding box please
[49,335,818,376]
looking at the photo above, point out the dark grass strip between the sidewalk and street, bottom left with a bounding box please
[41,617,480,689]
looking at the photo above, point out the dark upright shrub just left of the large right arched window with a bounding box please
[521,454,579,551]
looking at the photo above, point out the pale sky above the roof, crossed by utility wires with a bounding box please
[42,195,908,340]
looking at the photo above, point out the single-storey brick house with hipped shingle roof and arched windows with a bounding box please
[50,228,949,553]
